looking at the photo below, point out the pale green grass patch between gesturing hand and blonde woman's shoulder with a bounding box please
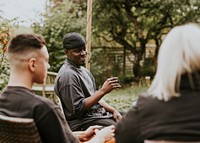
[103,86,147,112]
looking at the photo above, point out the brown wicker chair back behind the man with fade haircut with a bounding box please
[0,115,42,143]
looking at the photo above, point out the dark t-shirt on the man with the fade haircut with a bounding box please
[0,86,78,143]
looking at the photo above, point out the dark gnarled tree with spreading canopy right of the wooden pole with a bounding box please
[93,0,200,79]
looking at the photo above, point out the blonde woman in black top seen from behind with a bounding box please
[115,23,200,143]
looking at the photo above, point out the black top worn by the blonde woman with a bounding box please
[115,91,200,143]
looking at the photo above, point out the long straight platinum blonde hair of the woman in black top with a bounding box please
[147,23,200,101]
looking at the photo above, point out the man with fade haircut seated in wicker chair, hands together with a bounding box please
[0,34,114,143]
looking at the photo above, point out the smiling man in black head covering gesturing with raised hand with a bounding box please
[54,32,122,131]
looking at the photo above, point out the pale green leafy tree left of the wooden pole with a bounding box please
[32,0,86,72]
